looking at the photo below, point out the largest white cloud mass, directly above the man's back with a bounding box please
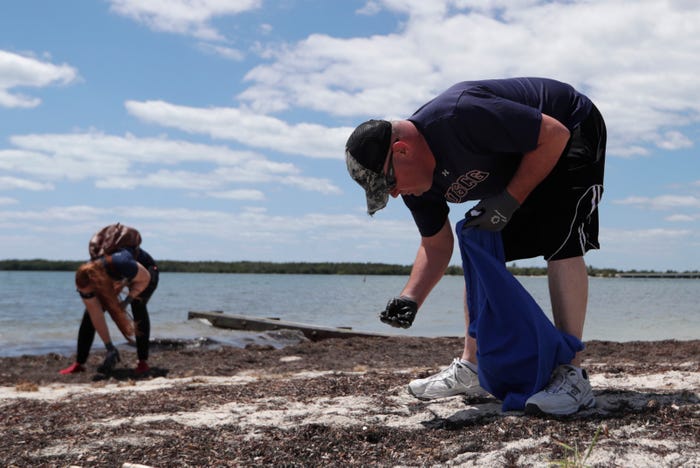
[239,0,700,157]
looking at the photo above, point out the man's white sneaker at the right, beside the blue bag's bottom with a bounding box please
[525,365,595,415]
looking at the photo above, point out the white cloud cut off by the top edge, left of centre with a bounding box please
[109,0,262,40]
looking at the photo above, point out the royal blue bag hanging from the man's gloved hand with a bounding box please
[456,220,583,411]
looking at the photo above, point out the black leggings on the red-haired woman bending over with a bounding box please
[75,265,158,364]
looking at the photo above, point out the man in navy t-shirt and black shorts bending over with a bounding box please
[345,78,606,414]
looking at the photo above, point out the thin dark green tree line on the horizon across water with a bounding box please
[0,259,699,277]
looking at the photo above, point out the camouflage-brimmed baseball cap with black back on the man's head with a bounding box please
[345,120,391,216]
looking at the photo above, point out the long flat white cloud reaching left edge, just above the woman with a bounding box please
[0,132,340,193]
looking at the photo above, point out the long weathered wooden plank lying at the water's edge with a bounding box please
[187,310,392,341]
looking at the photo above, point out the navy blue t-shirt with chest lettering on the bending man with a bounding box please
[402,78,593,237]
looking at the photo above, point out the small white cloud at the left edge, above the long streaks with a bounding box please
[0,50,78,108]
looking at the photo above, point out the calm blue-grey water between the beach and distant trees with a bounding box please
[0,271,700,356]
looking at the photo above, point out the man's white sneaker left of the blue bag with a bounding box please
[408,359,486,400]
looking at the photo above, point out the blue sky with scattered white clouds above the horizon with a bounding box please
[0,0,700,270]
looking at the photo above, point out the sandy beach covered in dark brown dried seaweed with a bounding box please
[0,337,700,467]
